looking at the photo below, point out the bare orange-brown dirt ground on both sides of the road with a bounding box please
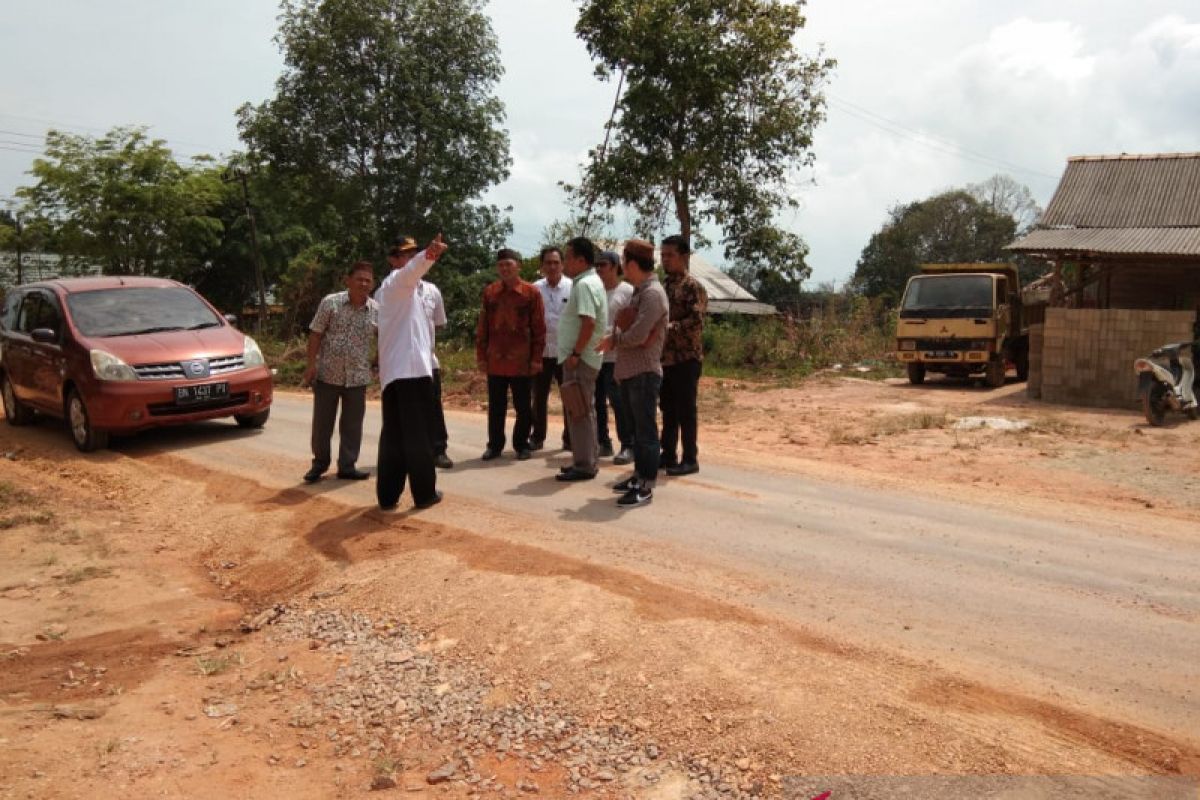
[0,373,1200,798]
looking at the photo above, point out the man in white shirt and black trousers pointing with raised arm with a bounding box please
[376,234,446,511]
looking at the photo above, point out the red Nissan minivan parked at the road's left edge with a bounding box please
[0,276,272,452]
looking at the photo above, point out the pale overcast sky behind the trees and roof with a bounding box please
[0,0,1200,284]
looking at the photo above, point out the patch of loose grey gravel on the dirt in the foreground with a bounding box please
[271,608,778,800]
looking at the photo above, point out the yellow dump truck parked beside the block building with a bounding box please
[896,264,1030,387]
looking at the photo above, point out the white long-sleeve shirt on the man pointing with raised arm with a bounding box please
[376,249,433,387]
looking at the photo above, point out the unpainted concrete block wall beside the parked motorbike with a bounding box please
[1030,308,1196,408]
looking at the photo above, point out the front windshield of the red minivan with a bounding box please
[67,287,222,337]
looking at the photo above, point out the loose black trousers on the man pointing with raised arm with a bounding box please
[376,378,438,506]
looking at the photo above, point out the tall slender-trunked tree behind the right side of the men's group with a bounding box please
[574,0,834,276]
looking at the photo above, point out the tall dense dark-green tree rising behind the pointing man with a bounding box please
[238,0,510,265]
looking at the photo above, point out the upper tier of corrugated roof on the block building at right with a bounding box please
[1038,152,1200,229]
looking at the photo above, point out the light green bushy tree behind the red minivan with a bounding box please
[17,127,221,277]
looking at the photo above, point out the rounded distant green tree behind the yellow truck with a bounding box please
[851,190,1016,303]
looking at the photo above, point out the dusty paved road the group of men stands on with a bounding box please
[108,393,1200,740]
